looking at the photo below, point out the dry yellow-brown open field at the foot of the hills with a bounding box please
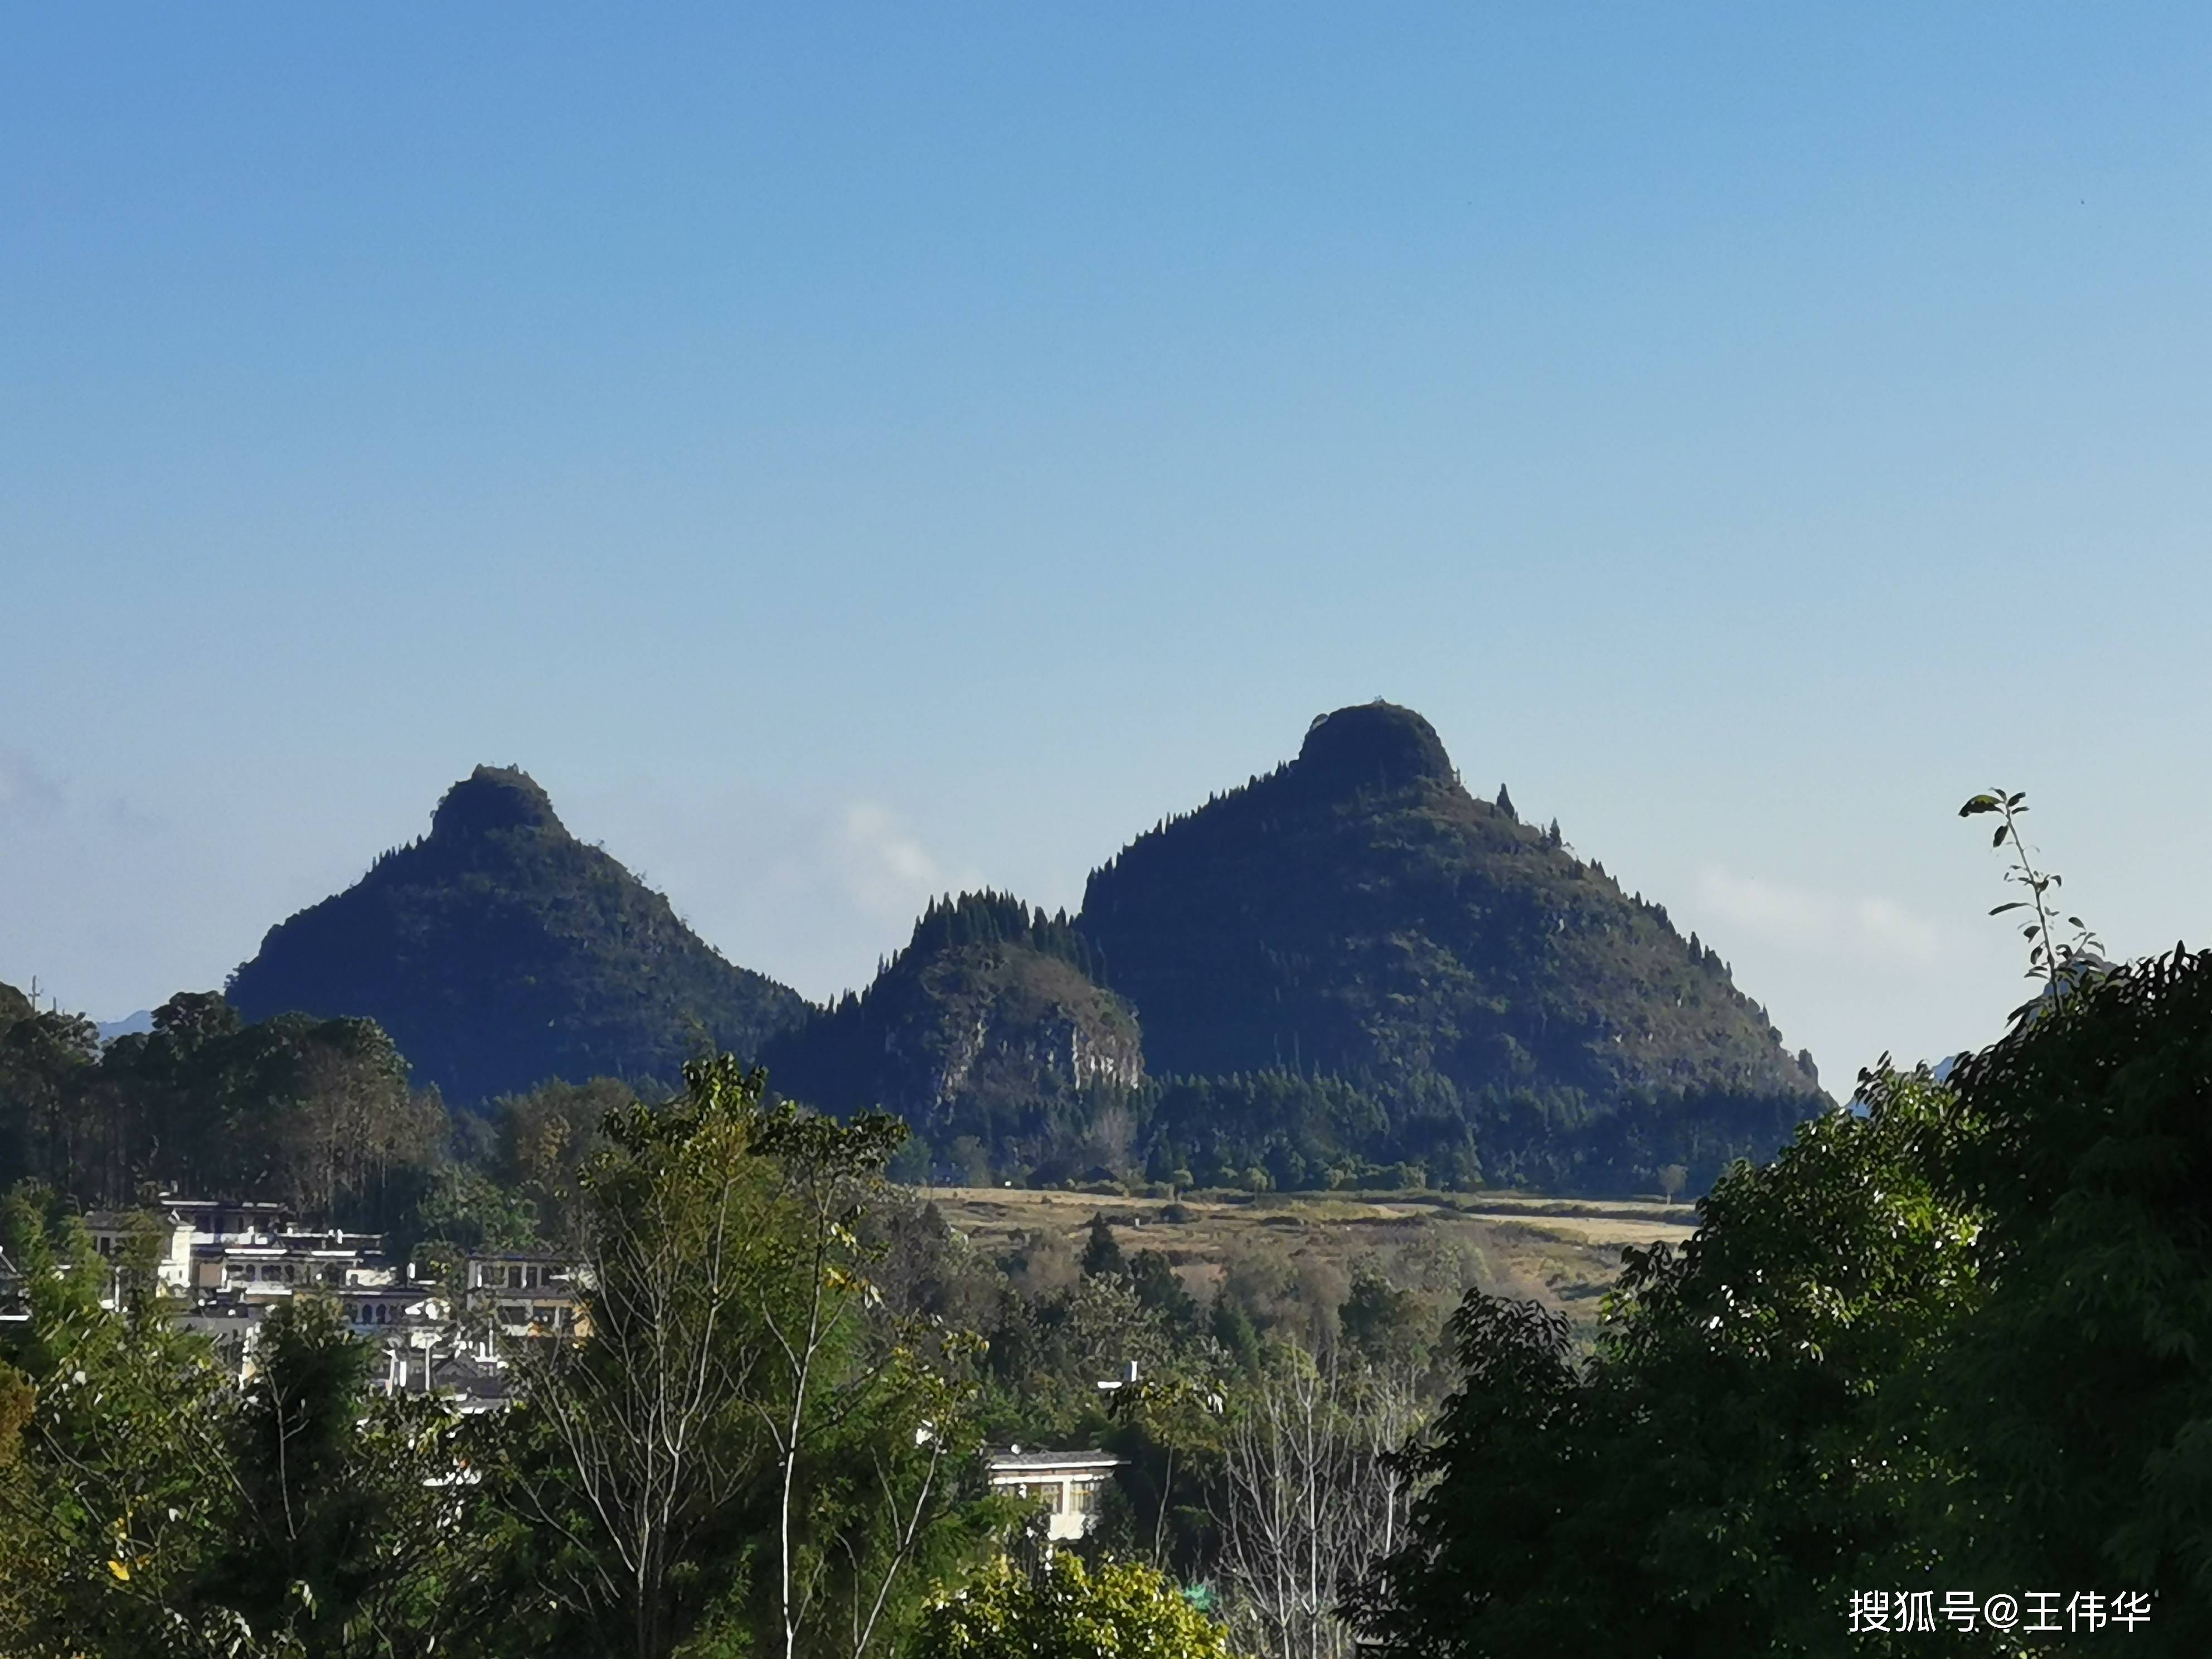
[918,1188,1694,1321]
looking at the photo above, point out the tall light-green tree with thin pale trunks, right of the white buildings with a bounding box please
[516,1058,973,1659]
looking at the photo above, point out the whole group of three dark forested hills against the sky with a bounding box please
[129,704,1821,1192]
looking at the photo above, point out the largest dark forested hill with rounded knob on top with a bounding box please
[1077,704,1825,1186]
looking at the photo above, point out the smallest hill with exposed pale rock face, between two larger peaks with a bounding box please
[765,894,1143,1175]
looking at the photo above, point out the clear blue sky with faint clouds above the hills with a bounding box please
[0,4,2212,1086]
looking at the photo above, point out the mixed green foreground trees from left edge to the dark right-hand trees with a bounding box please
[0,1039,1469,1659]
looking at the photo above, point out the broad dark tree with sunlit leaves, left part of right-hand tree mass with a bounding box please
[1356,1073,2015,1659]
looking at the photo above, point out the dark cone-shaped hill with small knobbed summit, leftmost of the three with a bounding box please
[226,765,807,1104]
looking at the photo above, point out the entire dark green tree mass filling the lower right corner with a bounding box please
[1360,949,2212,1659]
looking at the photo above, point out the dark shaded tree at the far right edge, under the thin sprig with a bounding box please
[1933,949,2212,1655]
